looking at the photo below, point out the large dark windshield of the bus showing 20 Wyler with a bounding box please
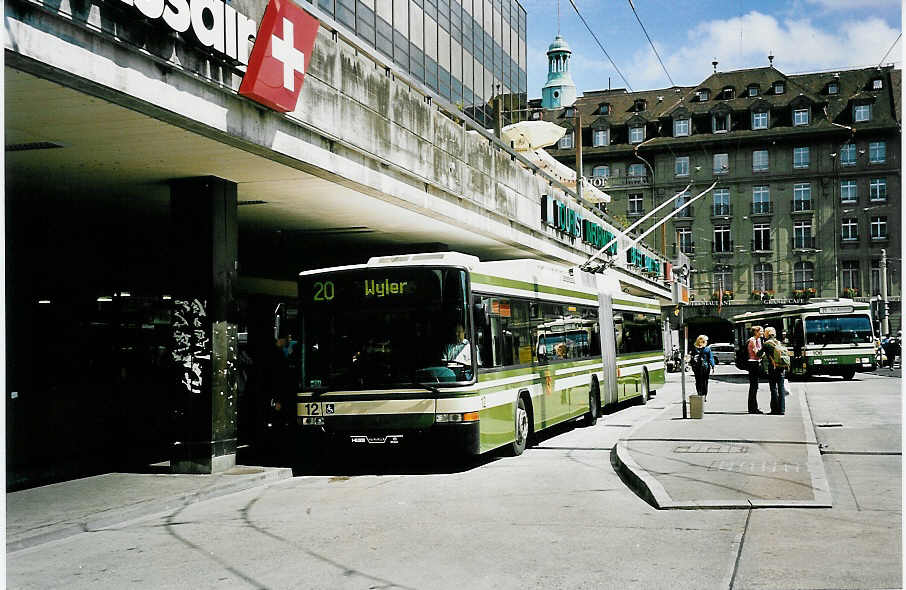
[299,267,474,390]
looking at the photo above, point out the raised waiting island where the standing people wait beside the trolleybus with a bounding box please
[614,367,831,509]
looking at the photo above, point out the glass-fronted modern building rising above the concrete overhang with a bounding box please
[309,0,528,121]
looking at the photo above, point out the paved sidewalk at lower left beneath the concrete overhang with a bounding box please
[6,465,292,554]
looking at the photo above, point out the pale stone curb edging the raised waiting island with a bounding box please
[610,385,833,510]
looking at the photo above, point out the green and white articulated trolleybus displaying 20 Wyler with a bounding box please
[296,252,664,455]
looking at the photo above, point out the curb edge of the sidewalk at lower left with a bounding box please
[6,467,293,555]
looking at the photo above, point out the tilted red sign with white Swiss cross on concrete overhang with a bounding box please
[239,0,318,113]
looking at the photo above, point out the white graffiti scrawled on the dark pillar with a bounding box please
[173,299,211,393]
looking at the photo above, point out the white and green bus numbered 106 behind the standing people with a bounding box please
[732,299,876,379]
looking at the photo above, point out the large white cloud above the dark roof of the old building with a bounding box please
[627,11,900,89]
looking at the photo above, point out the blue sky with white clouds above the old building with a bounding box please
[520,0,903,98]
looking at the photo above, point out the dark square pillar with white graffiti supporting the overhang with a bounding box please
[170,176,239,473]
